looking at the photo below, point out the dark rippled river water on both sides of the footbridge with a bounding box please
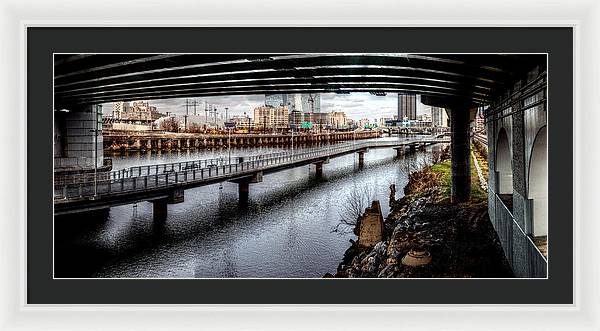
[54,138,436,278]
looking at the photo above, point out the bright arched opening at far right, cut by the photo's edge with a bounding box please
[527,126,548,237]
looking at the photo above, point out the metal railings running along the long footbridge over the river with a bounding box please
[54,139,450,199]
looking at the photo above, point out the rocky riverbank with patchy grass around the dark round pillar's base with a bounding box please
[334,150,512,278]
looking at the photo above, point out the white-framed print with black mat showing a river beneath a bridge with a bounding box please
[3,3,598,329]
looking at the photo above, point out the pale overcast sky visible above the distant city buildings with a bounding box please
[102,93,426,121]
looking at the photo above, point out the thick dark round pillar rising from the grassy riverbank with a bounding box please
[450,108,471,203]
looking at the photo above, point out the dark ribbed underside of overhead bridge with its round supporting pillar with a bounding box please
[54,54,546,206]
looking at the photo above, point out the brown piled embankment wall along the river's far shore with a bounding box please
[103,130,381,153]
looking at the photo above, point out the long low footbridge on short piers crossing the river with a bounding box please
[54,137,450,218]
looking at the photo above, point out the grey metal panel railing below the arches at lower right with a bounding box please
[492,193,548,278]
